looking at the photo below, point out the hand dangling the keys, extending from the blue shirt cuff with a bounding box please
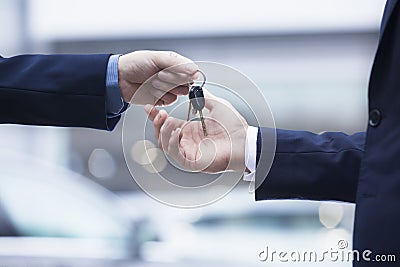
[118,51,198,105]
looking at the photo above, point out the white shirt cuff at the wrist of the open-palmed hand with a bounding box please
[243,126,258,182]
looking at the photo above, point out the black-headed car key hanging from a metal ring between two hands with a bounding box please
[187,71,207,136]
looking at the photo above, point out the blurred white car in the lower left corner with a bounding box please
[0,151,159,267]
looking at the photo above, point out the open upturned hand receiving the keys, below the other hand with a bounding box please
[145,90,248,173]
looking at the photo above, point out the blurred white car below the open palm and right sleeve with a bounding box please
[121,187,354,266]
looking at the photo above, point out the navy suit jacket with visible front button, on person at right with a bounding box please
[256,0,400,266]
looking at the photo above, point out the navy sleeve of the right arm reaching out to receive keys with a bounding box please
[256,128,365,202]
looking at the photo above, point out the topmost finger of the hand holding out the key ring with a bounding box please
[153,51,198,74]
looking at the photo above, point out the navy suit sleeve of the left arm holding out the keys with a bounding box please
[0,55,119,130]
